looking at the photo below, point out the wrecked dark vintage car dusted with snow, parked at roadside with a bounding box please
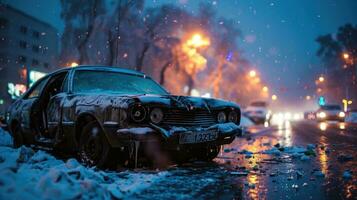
[6,66,241,167]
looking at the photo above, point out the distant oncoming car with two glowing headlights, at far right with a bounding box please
[316,104,346,122]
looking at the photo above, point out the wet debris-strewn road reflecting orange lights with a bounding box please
[134,121,357,199]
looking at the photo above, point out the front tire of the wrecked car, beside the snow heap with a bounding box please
[78,121,115,168]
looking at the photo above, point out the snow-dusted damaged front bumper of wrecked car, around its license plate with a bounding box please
[104,123,242,149]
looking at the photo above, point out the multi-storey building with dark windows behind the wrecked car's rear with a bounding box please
[0,3,59,114]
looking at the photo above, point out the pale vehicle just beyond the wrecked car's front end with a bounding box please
[244,101,270,124]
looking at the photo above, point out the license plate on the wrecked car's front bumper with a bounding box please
[180,130,218,144]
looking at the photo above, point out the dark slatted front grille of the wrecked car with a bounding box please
[163,110,216,127]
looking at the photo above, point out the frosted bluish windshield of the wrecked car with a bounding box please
[73,70,168,95]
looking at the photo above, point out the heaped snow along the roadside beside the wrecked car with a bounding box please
[0,129,169,199]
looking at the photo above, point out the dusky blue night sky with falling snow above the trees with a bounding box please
[0,0,357,105]
